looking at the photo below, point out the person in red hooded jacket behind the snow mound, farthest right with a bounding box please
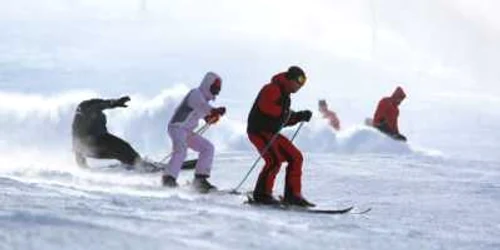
[372,87,406,141]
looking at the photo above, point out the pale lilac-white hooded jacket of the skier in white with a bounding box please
[168,72,222,131]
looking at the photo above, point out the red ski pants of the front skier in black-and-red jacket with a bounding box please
[248,132,303,197]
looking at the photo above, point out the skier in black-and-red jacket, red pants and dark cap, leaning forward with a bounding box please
[247,66,314,207]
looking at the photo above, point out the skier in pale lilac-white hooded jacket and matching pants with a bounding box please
[162,72,226,192]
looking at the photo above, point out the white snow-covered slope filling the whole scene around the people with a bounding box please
[0,0,500,250]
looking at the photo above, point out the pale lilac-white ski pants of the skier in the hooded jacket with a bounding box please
[165,125,214,179]
